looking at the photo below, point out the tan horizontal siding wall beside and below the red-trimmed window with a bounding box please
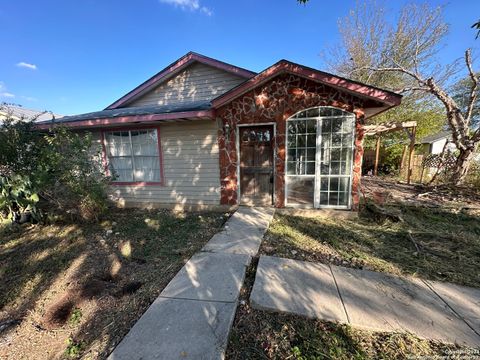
[103,120,220,206]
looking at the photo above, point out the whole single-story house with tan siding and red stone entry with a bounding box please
[39,52,401,209]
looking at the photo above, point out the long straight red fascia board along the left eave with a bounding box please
[36,110,215,130]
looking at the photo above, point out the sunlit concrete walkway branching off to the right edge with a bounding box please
[250,256,480,347]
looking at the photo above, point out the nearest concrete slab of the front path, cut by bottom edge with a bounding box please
[108,297,237,360]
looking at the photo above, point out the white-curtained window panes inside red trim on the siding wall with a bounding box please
[105,129,161,182]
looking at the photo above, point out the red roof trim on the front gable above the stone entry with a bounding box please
[212,60,402,108]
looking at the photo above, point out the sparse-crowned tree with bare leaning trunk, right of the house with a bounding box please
[316,0,480,184]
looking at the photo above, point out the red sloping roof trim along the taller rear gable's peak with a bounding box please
[105,51,256,110]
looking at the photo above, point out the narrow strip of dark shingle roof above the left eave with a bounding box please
[39,101,211,124]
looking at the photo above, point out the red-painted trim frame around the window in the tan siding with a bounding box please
[101,125,165,186]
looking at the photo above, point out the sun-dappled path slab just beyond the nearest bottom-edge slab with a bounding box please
[160,252,251,302]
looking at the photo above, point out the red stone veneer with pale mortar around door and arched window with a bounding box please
[217,74,364,208]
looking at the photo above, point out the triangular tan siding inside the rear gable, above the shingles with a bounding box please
[127,62,245,107]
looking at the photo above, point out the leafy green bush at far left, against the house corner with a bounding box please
[0,119,108,222]
